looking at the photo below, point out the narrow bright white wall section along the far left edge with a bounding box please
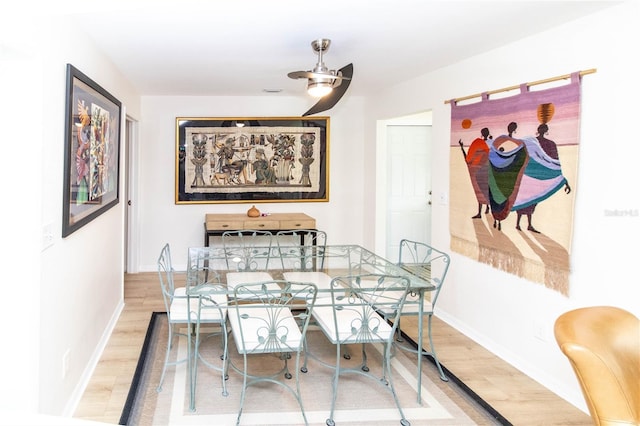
[0,17,43,412]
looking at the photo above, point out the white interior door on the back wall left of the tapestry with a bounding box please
[386,125,431,261]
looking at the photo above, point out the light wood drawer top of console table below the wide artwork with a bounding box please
[204,213,316,247]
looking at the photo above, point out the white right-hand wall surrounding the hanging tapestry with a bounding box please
[365,2,640,410]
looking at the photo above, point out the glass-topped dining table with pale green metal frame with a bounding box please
[187,241,435,403]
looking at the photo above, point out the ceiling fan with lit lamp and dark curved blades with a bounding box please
[287,38,353,116]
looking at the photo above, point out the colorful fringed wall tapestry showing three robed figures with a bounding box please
[450,72,580,295]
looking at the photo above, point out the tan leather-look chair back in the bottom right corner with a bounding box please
[555,306,640,426]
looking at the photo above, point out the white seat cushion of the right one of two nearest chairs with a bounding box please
[311,303,392,344]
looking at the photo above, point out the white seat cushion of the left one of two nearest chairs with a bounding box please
[229,304,302,354]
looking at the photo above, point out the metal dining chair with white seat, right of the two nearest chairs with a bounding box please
[312,274,410,426]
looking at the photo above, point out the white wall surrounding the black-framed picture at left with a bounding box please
[40,17,140,414]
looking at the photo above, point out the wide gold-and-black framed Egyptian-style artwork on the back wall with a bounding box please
[175,117,329,204]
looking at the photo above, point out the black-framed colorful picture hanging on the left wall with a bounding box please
[62,64,122,237]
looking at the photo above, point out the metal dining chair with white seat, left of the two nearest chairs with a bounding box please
[229,281,318,424]
